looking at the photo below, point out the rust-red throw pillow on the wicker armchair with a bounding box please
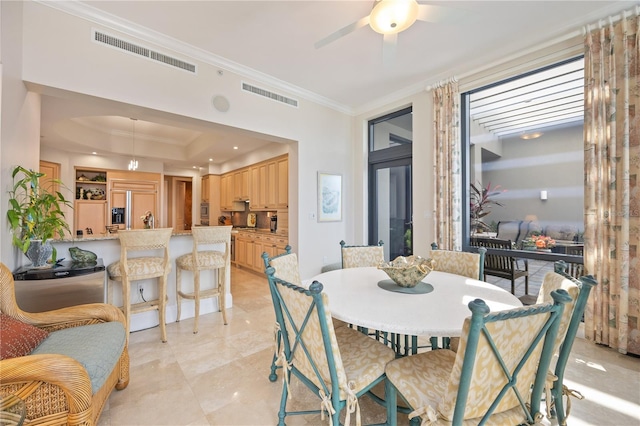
[0,313,49,359]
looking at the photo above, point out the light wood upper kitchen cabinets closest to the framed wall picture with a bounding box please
[249,155,289,211]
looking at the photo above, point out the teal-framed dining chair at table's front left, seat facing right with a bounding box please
[266,254,395,426]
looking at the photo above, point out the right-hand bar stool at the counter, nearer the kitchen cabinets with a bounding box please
[176,226,231,334]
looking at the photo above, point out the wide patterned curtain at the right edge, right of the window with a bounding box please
[584,10,640,354]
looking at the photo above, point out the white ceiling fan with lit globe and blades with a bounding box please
[315,0,460,63]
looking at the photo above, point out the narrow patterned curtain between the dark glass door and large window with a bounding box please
[433,81,462,250]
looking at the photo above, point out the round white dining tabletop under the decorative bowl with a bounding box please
[309,267,522,337]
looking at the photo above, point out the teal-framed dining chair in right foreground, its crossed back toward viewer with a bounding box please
[385,290,570,426]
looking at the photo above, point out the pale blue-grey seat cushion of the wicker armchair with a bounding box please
[32,321,126,394]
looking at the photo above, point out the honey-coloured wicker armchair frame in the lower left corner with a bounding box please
[0,264,129,425]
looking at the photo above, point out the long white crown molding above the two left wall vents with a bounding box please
[33,0,354,115]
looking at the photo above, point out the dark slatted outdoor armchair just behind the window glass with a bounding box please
[470,237,529,295]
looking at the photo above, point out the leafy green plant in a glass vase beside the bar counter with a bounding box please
[7,166,72,267]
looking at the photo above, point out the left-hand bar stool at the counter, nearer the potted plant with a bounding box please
[107,228,173,343]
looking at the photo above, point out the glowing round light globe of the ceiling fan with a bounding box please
[369,0,419,34]
